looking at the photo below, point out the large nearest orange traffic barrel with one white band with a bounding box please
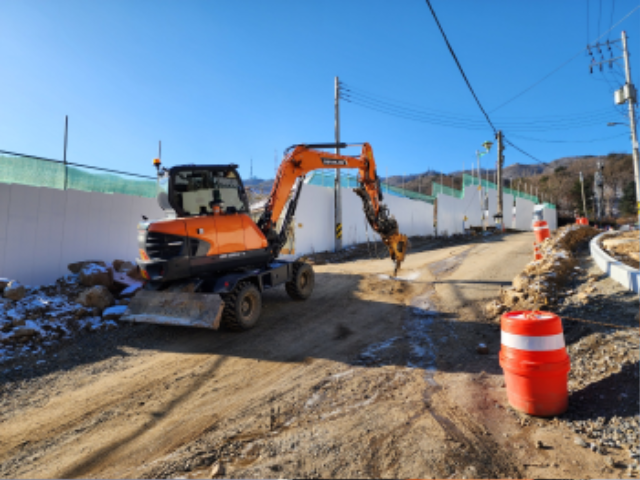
[500,311,571,417]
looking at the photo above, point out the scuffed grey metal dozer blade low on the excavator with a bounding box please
[120,290,224,330]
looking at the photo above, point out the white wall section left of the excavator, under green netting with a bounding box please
[0,183,164,285]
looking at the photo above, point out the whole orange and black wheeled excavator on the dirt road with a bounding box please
[122,143,408,330]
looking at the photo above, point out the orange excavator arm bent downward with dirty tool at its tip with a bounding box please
[258,143,408,273]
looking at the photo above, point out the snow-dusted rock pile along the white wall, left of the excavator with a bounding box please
[0,260,142,363]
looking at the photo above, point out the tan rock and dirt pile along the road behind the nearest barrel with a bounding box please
[485,224,598,317]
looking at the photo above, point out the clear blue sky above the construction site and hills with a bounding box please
[0,0,640,182]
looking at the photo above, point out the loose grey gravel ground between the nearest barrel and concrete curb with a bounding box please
[540,245,640,477]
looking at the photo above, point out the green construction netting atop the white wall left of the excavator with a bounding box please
[0,154,156,198]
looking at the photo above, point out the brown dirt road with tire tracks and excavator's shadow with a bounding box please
[0,234,632,478]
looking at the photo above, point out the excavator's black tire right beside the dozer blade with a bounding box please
[222,282,262,331]
